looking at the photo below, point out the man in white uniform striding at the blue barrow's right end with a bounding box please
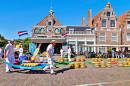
[43,40,56,75]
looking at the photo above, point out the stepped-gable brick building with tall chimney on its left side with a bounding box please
[87,1,121,53]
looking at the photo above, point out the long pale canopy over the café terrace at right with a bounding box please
[81,44,130,47]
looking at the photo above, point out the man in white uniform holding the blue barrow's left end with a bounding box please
[4,39,15,73]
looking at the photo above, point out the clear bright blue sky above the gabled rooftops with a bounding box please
[0,0,130,39]
